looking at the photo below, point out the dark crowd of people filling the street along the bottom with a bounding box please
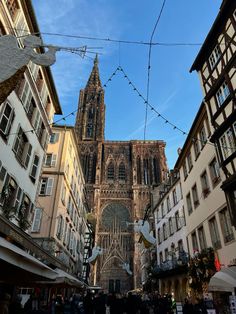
[0,290,211,314]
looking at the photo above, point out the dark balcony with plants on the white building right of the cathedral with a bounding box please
[152,251,189,278]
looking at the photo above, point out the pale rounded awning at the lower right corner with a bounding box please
[208,266,236,292]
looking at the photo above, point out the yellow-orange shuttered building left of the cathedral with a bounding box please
[31,126,88,278]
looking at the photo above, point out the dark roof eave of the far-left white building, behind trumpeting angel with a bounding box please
[21,0,62,114]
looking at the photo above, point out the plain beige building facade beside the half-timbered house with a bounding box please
[175,103,236,278]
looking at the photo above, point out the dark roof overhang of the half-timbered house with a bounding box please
[190,0,236,72]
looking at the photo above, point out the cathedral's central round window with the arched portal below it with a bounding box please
[97,203,134,292]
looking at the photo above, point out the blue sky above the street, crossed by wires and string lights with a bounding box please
[33,0,221,168]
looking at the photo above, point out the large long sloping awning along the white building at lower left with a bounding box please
[0,237,57,281]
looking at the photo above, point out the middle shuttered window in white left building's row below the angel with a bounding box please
[13,127,32,168]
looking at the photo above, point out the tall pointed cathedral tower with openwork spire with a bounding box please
[75,56,105,189]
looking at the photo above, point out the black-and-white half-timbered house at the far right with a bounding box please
[190,0,236,227]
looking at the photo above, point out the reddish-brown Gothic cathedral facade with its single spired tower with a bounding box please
[75,57,167,292]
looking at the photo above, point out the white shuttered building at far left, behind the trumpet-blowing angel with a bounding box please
[0,0,62,285]
